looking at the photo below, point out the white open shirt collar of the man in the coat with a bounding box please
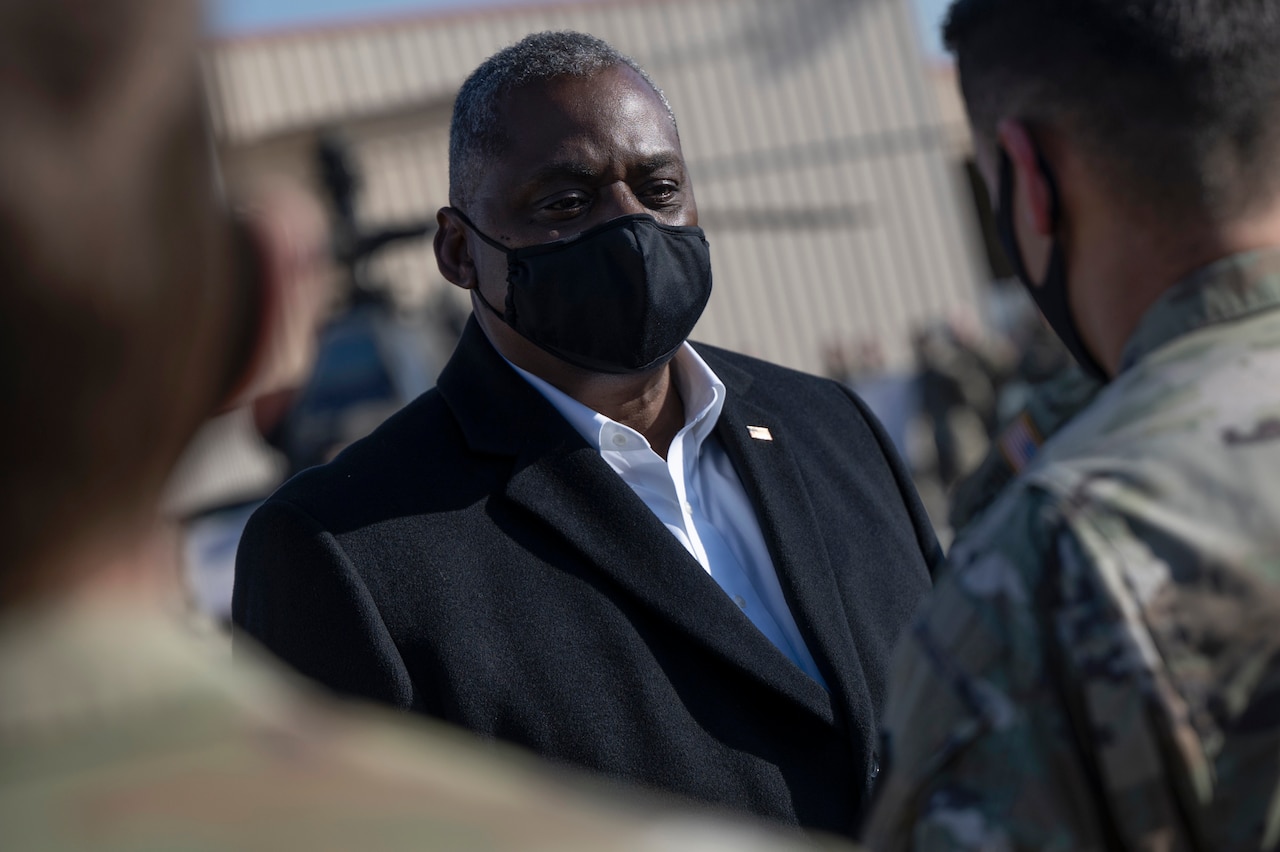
[507,343,724,450]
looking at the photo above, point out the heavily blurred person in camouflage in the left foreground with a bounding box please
[0,0,839,852]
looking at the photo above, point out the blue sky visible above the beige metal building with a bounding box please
[211,0,950,56]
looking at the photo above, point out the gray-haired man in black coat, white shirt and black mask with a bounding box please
[234,33,940,834]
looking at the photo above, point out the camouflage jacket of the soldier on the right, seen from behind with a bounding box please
[867,251,1280,851]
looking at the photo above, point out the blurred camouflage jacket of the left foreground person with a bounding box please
[0,609,837,852]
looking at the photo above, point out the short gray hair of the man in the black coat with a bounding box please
[449,31,676,207]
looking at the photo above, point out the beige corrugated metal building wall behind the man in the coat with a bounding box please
[209,0,979,371]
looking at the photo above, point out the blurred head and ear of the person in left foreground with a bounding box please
[0,0,320,606]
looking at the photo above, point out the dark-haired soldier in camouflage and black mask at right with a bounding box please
[865,0,1280,851]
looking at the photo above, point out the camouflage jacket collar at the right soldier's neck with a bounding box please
[1120,241,1280,372]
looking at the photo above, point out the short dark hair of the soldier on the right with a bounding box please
[943,0,1280,216]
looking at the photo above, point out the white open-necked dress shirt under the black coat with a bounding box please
[508,343,827,688]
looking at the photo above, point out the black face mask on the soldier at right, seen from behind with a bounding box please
[996,148,1110,381]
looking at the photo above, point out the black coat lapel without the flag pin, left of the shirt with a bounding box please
[439,319,835,723]
